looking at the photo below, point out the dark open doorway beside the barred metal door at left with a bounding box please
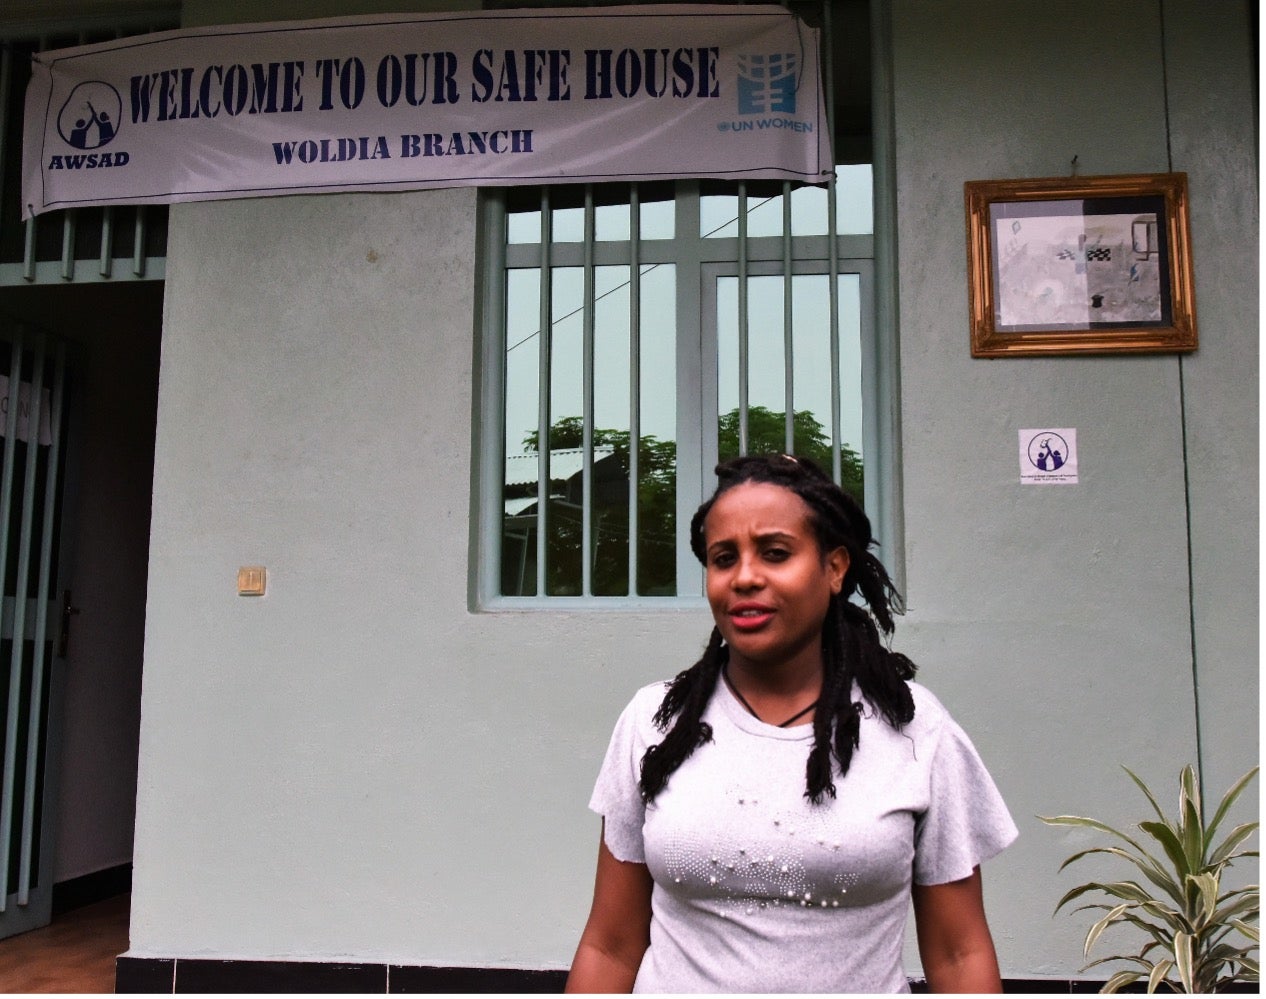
[0,281,163,942]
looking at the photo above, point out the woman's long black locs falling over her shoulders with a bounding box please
[641,455,915,804]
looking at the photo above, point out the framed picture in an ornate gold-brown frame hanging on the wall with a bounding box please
[965,173,1196,357]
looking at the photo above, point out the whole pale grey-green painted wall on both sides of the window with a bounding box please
[123,0,1257,976]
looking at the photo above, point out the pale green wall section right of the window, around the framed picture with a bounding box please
[893,0,1257,972]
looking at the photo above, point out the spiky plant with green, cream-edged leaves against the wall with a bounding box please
[1038,766,1260,993]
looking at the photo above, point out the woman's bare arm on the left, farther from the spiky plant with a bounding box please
[563,838,652,993]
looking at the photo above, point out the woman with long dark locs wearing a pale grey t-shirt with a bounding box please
[567,456,1015,993]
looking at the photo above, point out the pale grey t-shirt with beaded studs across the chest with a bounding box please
[590,682,1017,993]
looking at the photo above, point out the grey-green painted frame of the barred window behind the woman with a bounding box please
[468,0,905,612]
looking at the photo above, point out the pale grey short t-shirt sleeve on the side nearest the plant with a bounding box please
[914,715,1018,885]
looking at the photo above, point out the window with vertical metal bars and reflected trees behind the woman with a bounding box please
[477,4,879,606]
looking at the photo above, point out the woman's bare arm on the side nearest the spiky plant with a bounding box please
[913,867,1003,993]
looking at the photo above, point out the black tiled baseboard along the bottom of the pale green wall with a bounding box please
[114,957,1257,995]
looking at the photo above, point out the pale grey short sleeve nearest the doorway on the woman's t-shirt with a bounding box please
[589,685,663,864]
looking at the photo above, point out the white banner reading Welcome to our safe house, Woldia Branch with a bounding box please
[23,4,832,218]
